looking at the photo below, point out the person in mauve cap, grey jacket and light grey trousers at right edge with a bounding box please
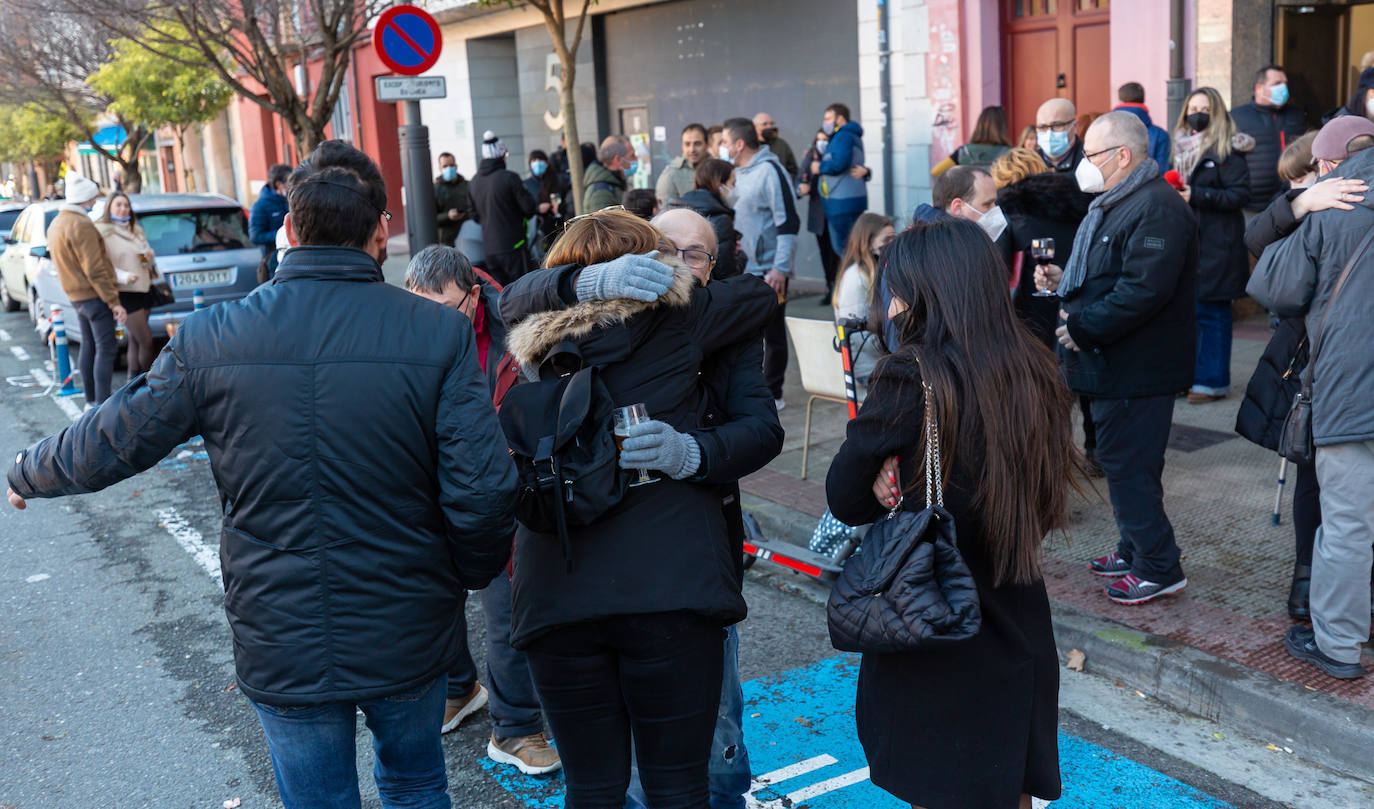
[1245,115,1374,680]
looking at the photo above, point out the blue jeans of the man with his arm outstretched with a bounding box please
[253,674,452,809]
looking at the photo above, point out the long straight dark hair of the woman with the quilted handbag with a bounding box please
[875,217,1083,585]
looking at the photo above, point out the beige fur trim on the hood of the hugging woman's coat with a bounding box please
[506,255,698,369]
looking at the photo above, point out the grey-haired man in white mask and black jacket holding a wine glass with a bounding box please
[1037,111,1198,604]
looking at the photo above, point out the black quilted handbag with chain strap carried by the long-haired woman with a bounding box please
[826,385,982,652]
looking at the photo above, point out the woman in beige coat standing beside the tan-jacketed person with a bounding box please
[95,192,158,379]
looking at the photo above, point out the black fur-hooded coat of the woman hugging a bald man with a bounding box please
[502,266,776,648]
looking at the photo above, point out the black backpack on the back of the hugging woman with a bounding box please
[500,341,629,567]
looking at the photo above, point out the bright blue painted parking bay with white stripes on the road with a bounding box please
[482,655,1232,809]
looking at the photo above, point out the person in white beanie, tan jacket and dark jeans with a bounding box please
[48,172,124,405]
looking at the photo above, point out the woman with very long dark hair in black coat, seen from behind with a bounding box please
[826,218,1081,809]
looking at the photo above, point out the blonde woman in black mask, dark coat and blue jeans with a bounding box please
[1173,87,1254,404]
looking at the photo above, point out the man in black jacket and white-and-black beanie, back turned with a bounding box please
[467,129,539,286]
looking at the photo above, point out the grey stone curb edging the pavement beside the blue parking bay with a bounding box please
[742,493,1374,782]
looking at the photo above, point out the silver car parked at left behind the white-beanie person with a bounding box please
[29,194,262,342]
